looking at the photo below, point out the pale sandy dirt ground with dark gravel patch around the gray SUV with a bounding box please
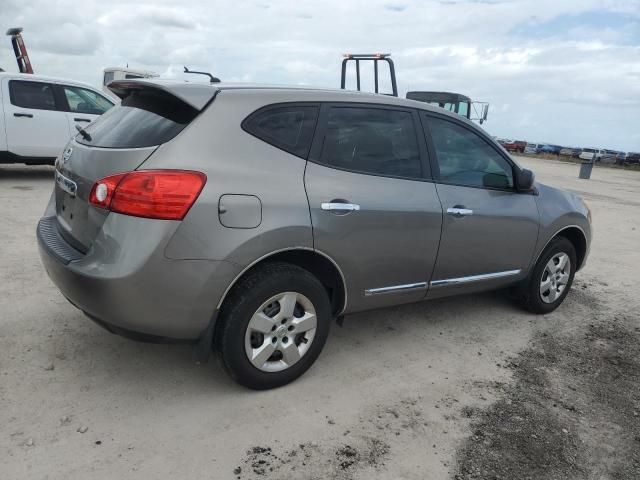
[0,158,640,480]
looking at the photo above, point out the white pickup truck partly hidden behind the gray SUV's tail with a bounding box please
[0,72,114,165]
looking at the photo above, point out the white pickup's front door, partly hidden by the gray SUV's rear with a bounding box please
[56,84,114,133]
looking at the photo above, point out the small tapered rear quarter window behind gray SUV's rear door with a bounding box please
[242,105,318,158]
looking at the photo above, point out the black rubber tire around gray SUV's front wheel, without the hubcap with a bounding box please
[518,237,578,314]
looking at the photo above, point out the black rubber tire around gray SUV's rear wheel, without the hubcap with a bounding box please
[214,262,331,390]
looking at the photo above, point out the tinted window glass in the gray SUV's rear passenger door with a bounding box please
[320,107,422,178]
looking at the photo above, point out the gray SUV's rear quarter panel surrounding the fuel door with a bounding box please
[141,90,313,267]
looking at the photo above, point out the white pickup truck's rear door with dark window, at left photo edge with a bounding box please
[2,79,71,159]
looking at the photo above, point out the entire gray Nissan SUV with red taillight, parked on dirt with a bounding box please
[37,80,591,389]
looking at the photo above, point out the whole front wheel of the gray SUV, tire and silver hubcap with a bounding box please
[519,237,578,314]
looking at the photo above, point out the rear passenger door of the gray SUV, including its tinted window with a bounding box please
[305,104,442,311]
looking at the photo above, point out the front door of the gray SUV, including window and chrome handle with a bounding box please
[422,114,539,298]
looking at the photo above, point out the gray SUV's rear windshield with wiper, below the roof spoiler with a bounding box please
[76,90,198,148]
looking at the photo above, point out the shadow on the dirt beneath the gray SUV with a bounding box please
[50,292,530,401]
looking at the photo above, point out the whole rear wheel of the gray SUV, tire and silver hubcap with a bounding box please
[215,263,331,390]
